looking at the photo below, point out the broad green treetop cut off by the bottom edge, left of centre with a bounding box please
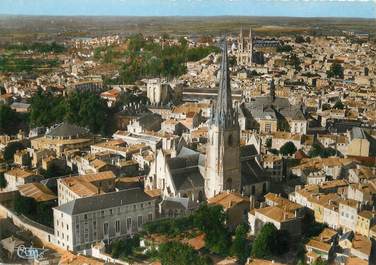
[159,241,212,265]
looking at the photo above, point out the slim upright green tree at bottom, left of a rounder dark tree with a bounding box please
[230,224,250,264]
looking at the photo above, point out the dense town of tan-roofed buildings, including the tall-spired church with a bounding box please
[0,24,376,265]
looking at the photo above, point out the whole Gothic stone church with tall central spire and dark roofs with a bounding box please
[145,38,269,202]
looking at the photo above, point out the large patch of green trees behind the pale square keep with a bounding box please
[98,34,220,84]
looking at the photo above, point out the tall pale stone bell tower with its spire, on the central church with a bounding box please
[205,39,241,198]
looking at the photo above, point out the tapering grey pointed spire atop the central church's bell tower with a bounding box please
[212,37,238,128]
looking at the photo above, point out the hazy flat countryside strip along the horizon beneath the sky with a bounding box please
[0,16,376,43]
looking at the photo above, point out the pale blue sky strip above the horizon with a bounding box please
[0,0,376,18]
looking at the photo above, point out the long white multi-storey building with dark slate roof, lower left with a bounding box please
[53,188,156,251]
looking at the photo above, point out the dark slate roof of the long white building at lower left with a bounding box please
[55,188,154,215]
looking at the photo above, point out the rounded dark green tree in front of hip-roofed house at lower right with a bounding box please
[251,223,278,258]
